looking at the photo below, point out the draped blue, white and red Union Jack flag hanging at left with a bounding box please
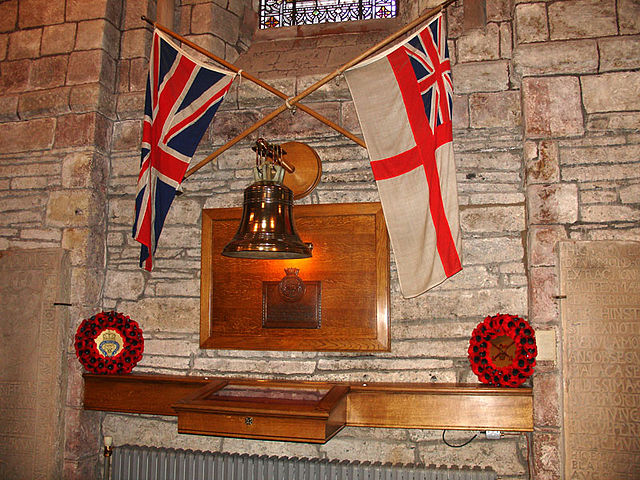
[133,30,235,271]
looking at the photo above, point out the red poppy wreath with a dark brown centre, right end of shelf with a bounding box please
[469,314,538,387]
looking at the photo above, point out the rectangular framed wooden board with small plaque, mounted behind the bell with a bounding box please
[200,203,390,351]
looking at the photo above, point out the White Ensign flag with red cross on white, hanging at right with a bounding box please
[345,15,462,297]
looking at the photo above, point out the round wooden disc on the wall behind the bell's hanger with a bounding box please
[282,142,322,200]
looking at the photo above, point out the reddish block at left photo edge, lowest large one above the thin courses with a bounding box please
[0,118,56,153]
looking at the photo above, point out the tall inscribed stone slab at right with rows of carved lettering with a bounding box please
[559,241,640,480]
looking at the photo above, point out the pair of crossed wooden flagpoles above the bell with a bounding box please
[142,0,456,178]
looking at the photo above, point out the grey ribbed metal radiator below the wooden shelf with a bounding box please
[111,445,496,480]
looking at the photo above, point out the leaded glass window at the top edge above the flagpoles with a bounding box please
[260,0,396,28]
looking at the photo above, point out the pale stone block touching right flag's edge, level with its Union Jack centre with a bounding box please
[452,60,509,94]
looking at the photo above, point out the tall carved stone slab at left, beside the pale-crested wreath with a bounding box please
[0,249,69,480]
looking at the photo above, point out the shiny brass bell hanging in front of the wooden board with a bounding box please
[222,180,312,260]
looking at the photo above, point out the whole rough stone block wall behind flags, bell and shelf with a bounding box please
[0,0,640,479]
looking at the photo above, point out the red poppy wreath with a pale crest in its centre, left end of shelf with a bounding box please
[74,312,144,374]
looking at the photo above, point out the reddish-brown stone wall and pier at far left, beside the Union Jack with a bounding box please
[0,0,122,478]
